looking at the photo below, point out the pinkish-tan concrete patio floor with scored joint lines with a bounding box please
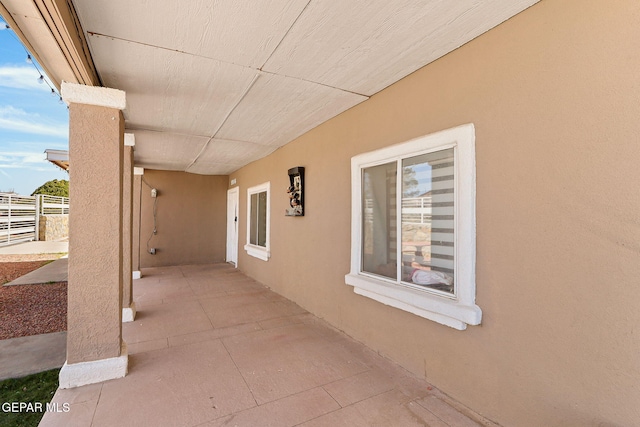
[40,264,495,427]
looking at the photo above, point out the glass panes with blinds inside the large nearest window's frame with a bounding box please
[362,148,455,292]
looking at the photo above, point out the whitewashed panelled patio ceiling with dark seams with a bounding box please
[73,0,538,175]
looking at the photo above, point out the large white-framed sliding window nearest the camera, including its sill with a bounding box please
[346,124,482,329]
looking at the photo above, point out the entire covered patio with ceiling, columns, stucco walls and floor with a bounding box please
[0,0,640,427]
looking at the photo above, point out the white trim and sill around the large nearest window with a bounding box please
[345,123,482,330]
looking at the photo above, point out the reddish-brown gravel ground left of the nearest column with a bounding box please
[0,254,67,340]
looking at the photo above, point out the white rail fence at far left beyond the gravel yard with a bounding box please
[0,193,69,246]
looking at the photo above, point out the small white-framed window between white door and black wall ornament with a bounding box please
[244,182,270,261]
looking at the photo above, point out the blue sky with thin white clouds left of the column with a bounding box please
[0,19,69,195]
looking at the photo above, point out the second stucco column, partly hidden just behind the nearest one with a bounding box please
[122,133,136,322]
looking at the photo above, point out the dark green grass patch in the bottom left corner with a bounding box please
[0,369,60,427]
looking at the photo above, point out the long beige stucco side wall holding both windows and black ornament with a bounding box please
[230,0,640,426]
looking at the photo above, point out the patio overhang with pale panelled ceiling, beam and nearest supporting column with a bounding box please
[0,0,538,388]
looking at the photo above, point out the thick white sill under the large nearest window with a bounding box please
[345,274,482,331]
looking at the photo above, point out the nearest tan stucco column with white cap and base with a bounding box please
[60,82,128,388]
